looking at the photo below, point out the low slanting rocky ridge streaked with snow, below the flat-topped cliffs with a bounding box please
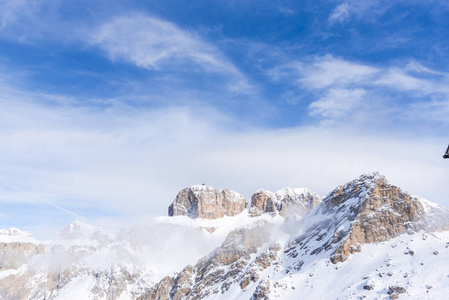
[138,223,281,300]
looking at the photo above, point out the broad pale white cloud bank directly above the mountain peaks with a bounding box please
[0,84,449,237]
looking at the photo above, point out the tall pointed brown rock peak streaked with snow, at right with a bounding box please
[286,173,449,269]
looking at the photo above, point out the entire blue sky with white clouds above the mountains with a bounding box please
[0,0,449,236]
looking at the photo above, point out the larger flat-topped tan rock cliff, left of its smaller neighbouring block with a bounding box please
[168,185,246,219]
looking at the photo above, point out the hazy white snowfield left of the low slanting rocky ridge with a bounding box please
[0,210,283,299]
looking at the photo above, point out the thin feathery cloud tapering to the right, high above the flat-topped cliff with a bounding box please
[91,14,239,74]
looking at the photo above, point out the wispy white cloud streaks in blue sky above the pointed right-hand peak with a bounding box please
[269,55,449,125]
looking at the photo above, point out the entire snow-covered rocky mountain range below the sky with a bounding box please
[0,173,449,300]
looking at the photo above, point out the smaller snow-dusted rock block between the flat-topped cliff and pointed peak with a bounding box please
[250,188,321,217]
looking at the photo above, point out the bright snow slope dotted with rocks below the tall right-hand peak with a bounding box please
[212,232,449,300]
